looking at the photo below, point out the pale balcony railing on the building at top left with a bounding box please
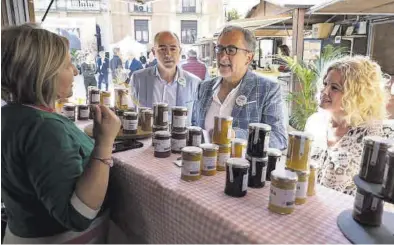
[34,0,106,12]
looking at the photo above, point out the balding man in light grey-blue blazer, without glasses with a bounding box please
[130,31,201,122]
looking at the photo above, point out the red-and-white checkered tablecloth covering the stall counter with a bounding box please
[76,121,353,243]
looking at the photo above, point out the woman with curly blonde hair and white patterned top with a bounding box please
[305,56,387,195]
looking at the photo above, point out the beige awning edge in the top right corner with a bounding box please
[310,0,394,15]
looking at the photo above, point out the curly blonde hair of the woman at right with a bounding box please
[323,56,387,127]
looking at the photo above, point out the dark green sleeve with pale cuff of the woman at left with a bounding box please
[25,120,99,231]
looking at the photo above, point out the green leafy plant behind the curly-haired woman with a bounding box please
[279,45,348,131]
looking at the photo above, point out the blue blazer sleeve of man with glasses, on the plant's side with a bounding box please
[261,83,287,150]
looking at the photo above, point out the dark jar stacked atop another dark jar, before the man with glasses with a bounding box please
[247,123,271,158]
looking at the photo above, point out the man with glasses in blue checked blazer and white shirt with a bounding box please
[192,26,287,150]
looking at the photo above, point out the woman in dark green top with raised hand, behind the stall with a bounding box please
[1,24,120,243]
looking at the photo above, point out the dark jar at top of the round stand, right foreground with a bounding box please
[359,136,393,184]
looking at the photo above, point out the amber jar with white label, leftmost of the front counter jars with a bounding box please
[181,146,202,181]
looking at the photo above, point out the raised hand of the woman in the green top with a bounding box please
[92,105,121,148]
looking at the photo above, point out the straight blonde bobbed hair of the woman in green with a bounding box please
[1,24,68,107]
